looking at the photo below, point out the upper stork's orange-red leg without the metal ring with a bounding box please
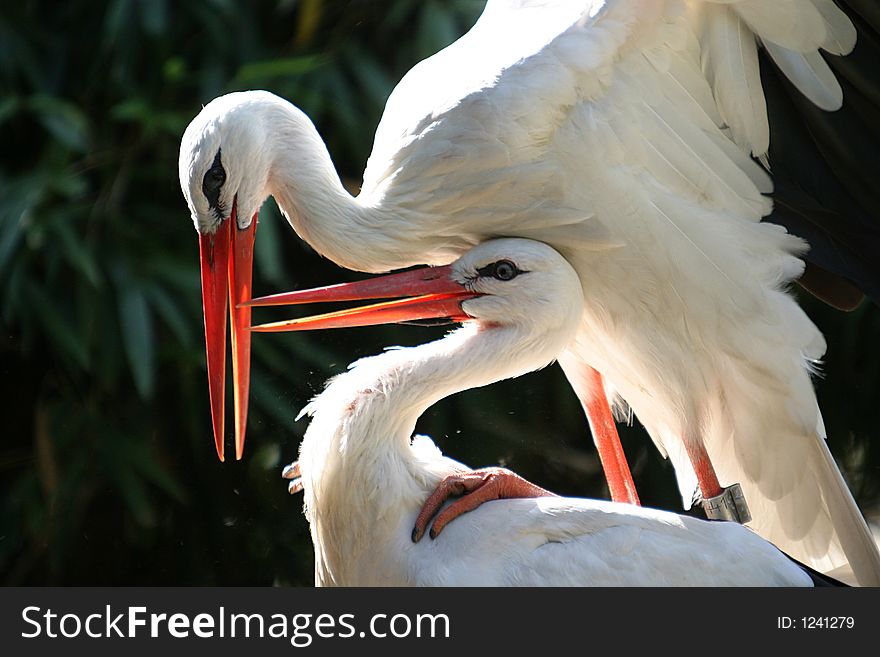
[559,352,640,506]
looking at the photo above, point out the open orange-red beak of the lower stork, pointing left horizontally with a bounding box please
[244,265,480,333]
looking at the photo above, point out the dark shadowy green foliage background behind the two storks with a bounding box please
[0,0,880,585]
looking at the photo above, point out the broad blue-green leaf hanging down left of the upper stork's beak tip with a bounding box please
[119,285,156,399]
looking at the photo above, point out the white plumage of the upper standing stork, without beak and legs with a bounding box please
[180,0,880,585]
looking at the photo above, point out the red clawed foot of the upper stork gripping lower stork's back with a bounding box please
[412,468,557,543]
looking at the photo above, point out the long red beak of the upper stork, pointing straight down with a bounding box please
[199,205,257,461]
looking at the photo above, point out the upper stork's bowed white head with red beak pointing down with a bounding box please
[179,91,277,460]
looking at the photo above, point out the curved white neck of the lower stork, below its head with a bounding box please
[300,324,561,584]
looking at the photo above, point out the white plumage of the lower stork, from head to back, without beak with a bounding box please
[299,239,811,586]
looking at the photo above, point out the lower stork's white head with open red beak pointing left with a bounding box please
[247,238,583,376]
